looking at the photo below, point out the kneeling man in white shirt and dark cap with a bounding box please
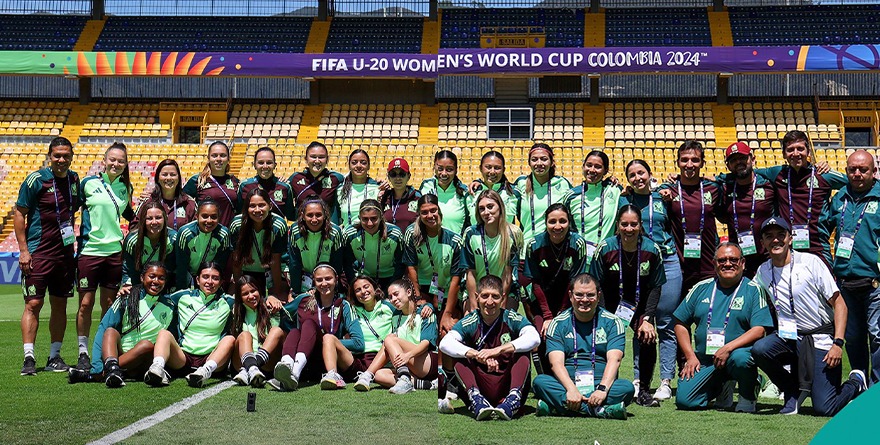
[752,217,867,416]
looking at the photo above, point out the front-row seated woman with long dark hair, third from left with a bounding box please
[232,275,284,388]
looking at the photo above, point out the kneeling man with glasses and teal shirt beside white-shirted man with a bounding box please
[672,243,773,413]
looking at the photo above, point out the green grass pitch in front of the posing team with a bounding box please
[0,286,846,445]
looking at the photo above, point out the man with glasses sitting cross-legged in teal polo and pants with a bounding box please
[535,274,635,420]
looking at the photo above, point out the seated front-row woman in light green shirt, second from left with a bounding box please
[144,263,235,388]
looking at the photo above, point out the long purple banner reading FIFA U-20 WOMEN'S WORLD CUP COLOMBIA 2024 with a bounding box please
[0,45,880,79]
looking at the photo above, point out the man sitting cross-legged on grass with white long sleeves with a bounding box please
[440,275,541,420]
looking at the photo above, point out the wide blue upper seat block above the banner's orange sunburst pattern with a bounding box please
[95,16,312,53]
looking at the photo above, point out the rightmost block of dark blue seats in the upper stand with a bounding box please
[728,5,880,45]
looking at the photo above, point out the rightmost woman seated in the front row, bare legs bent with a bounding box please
[354,278,438,394]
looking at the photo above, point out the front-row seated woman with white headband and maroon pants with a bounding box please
[267,263,364,391]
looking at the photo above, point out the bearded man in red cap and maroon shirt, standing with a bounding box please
[718,142,776,278]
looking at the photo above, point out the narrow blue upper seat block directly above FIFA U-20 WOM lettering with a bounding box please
[324,17,424,53]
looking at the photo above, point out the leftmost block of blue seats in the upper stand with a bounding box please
[0,14,87,51]
